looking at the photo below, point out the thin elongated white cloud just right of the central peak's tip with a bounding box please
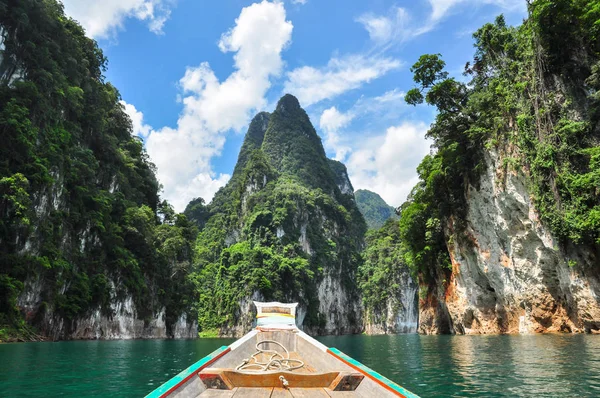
[284,55,402,107]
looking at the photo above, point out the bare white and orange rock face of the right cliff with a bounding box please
[419,151,600,334]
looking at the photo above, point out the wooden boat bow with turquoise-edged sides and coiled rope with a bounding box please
[147,303,418,398]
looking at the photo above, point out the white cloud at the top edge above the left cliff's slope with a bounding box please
[63,0,173,39]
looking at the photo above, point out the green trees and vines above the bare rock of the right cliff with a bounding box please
[399,0,600,281]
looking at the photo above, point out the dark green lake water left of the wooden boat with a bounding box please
[0,339,234,397]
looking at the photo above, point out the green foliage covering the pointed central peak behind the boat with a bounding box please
[192,95,366,333]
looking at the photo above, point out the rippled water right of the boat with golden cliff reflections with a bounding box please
[320,335,600,397]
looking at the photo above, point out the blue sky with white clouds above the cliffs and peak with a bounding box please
[63,0,526,211]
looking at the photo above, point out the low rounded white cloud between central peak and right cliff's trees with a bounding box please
[346,122,430,206]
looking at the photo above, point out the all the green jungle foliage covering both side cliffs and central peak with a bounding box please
[0,0,600,340]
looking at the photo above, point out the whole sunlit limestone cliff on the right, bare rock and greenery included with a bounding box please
[400,9,600,334]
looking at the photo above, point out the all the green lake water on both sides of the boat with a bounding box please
[0,335,600,397]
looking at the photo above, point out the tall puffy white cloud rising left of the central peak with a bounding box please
[120,1,293,211]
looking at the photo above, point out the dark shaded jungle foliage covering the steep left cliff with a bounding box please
[0,0,197,340]
